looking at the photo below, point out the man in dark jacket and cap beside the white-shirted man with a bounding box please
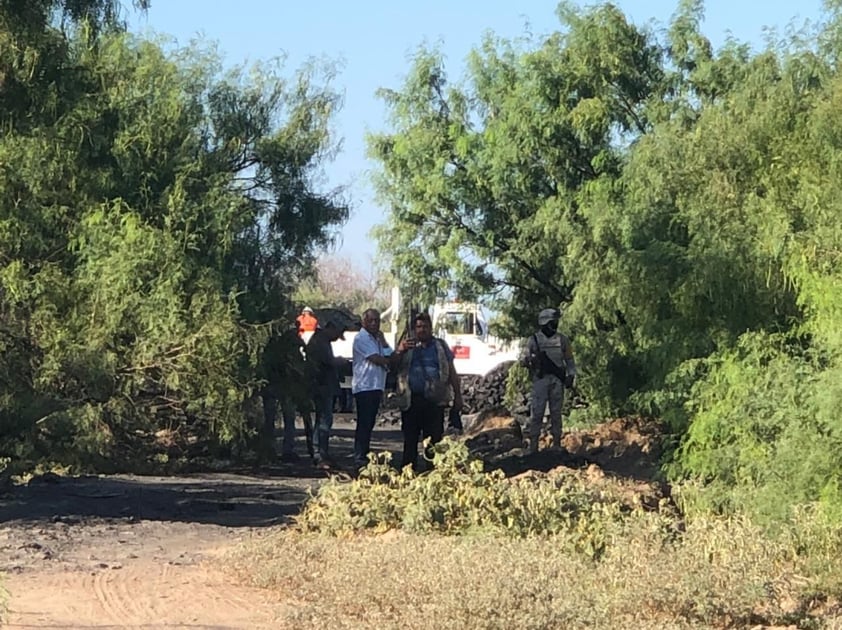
[306,317,347,468]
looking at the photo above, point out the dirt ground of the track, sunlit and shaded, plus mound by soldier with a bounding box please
[0,418,656,629]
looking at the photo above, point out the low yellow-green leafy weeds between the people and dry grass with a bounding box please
[297,440,664,558]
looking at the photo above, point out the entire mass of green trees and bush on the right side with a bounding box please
[370,1,842,518]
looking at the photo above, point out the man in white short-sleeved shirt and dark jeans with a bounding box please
[351,308,392,468]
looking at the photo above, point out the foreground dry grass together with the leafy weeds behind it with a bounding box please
[223,445,842,630]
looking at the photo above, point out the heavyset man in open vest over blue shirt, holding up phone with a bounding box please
[395,313,463,470]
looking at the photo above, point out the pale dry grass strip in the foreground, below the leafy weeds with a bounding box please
[229,519,842,629]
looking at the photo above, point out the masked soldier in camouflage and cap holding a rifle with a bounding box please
[523,308,576,453]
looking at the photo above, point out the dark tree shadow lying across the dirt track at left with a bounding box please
[0,421,401,527]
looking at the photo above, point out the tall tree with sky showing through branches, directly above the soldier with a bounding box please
[370,5,665,400]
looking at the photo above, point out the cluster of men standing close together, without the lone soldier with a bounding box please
[263,309,463,469]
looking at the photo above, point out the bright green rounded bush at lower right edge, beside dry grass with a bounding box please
[671,333,842,523]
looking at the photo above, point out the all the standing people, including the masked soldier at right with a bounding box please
[263,309,576,469]
